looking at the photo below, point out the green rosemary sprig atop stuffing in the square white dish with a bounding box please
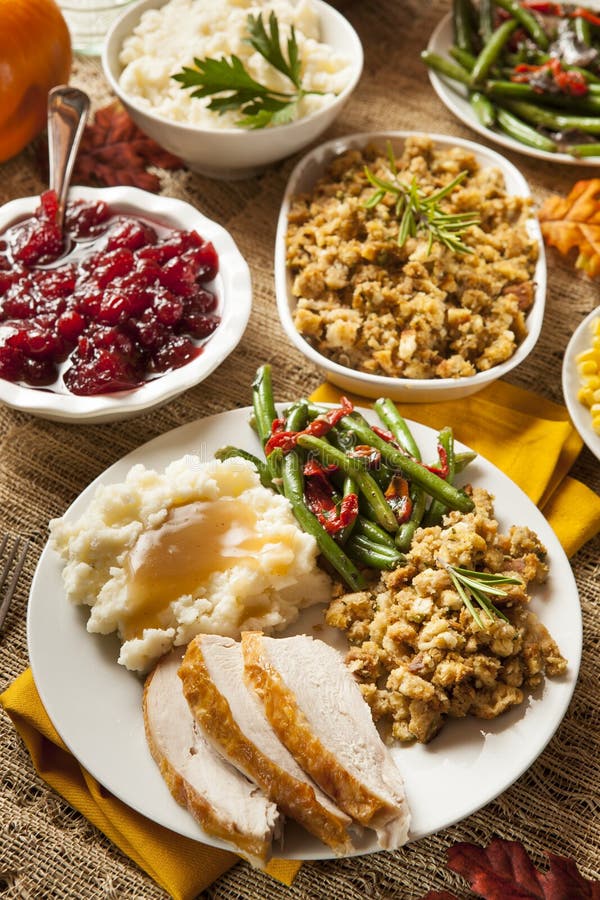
[364,141,479,254]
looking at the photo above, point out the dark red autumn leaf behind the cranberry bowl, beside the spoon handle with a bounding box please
[40,102,183,192]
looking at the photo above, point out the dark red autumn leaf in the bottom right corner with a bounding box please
[424,838,600,900]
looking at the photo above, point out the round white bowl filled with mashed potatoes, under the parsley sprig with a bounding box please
[102,0,363,178]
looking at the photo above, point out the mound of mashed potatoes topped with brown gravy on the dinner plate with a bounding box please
[50,456,330,672]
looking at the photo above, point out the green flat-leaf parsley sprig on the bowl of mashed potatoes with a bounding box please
[173,12,322,128]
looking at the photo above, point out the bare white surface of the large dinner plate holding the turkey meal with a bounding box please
[27,409,581,859]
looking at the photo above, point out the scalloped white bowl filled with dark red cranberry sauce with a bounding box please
[0,187,252,423]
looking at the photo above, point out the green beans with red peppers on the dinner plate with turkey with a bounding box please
[224,365,475,591]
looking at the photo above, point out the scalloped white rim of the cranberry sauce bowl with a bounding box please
[0,187,252,422]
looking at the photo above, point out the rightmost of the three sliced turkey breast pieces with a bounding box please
[242,632,410,850]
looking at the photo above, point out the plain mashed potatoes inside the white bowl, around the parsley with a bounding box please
[119,0,351,129]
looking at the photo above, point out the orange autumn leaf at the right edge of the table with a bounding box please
[538,178,600,278]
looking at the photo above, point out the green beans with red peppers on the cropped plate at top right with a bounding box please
[421,0,600,158]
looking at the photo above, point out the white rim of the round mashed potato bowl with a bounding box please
[102,0,364,141]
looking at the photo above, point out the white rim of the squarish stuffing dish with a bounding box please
[275,131,546,402]
